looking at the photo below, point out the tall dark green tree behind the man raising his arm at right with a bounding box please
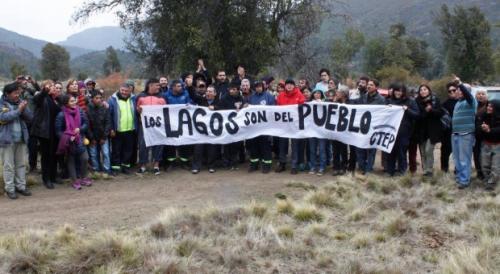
[435,5,494,81]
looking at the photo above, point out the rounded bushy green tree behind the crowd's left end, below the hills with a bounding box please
[40,43,71,80]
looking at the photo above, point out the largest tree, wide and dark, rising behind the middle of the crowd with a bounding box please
[74,0,326,74]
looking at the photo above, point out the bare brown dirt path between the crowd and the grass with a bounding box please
[0,169,320,233]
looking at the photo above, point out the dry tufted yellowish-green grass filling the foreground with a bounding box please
[0,174,500,273]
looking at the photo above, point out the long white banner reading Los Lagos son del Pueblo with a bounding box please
[141,103,404,152]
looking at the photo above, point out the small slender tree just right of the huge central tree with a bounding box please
[332,29,365,79]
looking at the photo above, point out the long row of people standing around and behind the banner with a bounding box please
[0,60,500,199]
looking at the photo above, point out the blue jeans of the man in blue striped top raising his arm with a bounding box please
[451,133,476,186]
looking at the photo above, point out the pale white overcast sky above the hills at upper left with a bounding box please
[0,0,118,42]
